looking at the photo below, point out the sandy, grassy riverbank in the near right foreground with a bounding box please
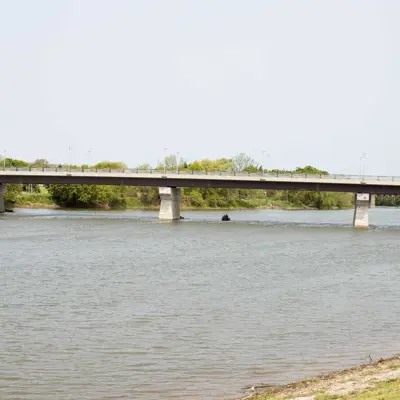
[241,356,400,400]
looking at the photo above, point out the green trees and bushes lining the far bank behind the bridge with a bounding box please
[0,153,390,210]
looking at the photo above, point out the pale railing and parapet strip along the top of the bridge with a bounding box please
[0,167,400,182]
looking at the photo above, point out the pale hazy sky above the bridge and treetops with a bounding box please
[0,0,400,175]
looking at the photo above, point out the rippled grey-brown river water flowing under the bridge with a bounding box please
[0,209,400,400]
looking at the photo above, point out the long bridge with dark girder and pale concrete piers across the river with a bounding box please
[0,168,400,228]
